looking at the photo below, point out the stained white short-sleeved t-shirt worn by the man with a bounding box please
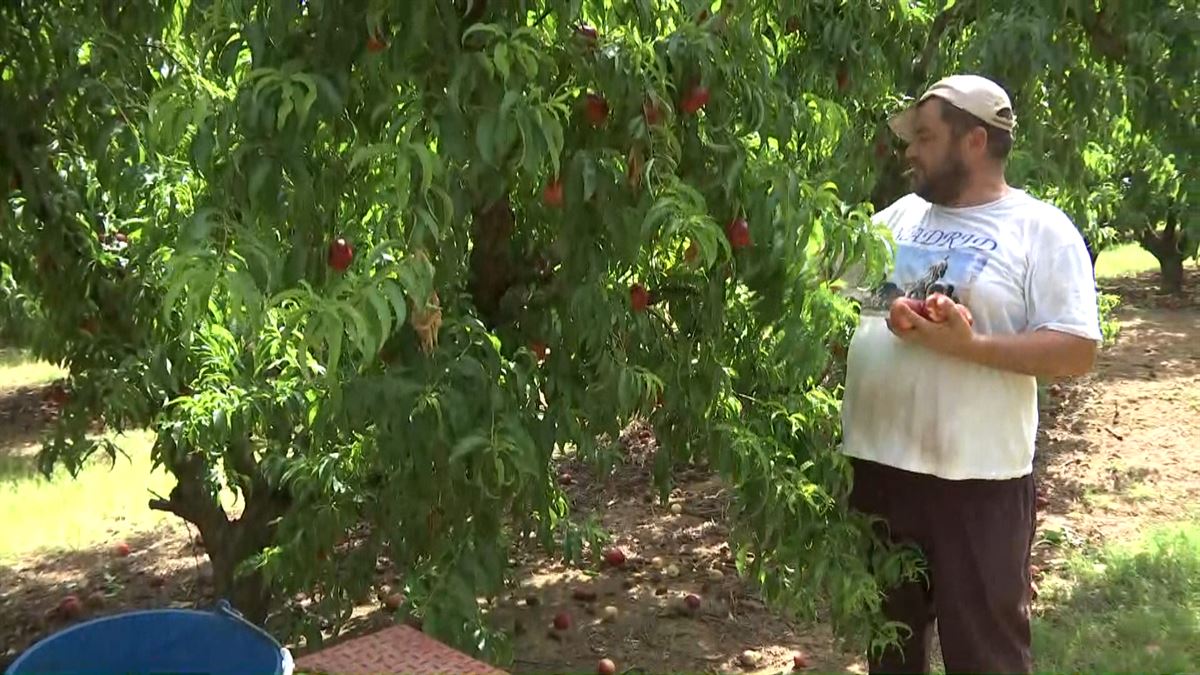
[842,189,1102,479]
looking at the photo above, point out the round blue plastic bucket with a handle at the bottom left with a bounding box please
[6,601,292,675]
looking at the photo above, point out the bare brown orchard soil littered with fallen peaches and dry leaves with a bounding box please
[0,269,1200,673]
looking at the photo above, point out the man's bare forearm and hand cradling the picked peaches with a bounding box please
[892,295,1097,377]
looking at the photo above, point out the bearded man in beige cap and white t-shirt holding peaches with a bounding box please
[842,76,1102,673]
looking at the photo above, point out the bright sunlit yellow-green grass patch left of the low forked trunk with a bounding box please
[0,432,178,562]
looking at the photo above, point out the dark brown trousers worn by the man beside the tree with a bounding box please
[850,458,1037,674]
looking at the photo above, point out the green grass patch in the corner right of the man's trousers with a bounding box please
[1033,522,1200,673]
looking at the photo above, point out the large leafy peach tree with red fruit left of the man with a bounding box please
[0,0,934,651]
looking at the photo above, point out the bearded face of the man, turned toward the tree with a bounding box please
[905,98,971,204]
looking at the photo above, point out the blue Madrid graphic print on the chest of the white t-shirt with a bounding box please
[870,222,997,311]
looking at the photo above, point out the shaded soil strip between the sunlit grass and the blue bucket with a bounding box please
[0,530,214,670]
